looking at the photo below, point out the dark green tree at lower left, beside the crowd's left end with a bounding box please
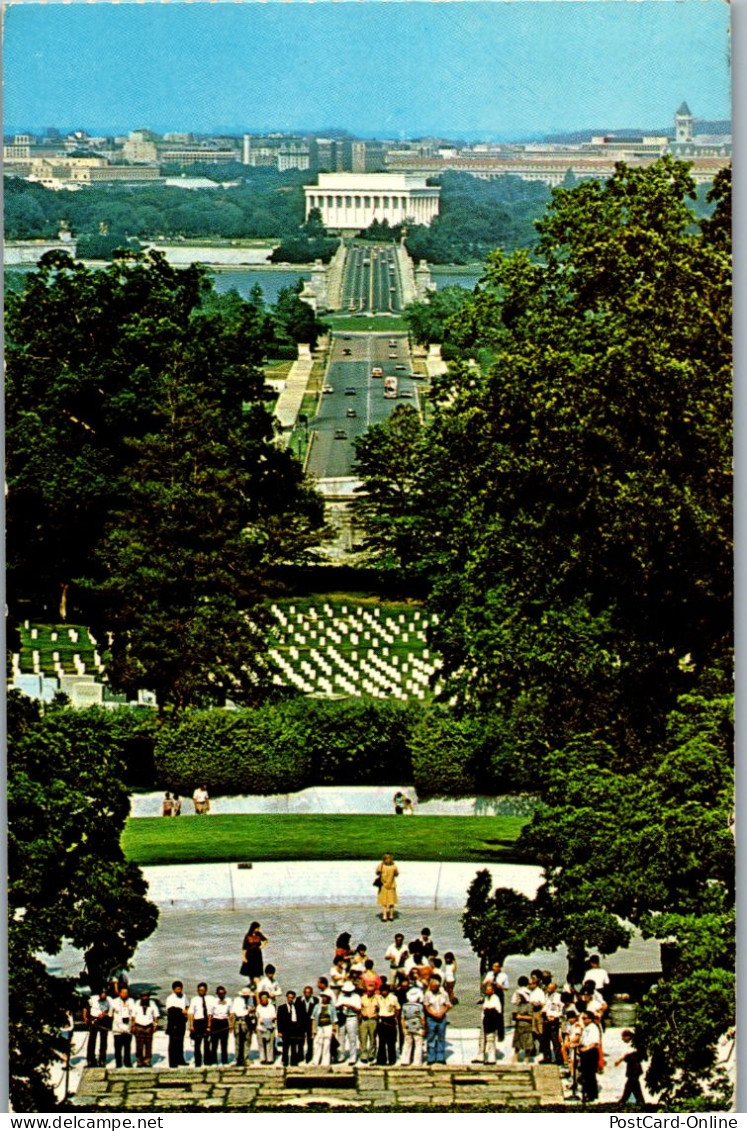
[8,692,157,1111]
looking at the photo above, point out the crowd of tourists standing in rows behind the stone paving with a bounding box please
[80,936,643,1103]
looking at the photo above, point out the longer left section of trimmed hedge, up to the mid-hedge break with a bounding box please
[155,699,423,795]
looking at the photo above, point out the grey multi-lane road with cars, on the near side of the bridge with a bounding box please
[308,334,418,480]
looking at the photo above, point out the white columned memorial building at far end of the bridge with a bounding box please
[303,173,441,232]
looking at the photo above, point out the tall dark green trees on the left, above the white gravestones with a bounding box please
[7,253,321,706]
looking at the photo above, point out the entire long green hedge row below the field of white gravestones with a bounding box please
[155,699,536,798]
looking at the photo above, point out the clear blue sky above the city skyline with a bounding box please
[5,0,730,137]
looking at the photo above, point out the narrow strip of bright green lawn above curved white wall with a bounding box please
[122,813,527,864]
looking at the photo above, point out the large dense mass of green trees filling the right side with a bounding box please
[359,159,733,1102]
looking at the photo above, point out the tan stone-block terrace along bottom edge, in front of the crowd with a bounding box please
[75,1064,564,1112]
